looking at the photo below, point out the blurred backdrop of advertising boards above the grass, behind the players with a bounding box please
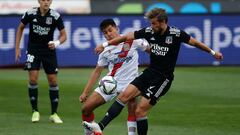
[0,0,240,67]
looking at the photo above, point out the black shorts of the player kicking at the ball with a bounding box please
[131,69,173,105]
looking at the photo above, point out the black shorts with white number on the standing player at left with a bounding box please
[24,51,58,74]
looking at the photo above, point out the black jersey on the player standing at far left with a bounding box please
[21,7,64,49]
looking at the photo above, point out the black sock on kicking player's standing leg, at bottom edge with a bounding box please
[137,117,148,135]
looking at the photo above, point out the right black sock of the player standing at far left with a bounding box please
[49,86,59,114]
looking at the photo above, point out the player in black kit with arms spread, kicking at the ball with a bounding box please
[83,8,223,135]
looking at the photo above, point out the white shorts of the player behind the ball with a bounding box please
[94,81,131,102]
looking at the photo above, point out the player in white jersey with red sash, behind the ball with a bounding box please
[79,19,149,135]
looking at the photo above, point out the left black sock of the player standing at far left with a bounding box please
[28,83,38,111]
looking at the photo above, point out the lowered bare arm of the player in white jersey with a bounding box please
[79,66,104,103]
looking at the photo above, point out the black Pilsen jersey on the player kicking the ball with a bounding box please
[134,26,190,76]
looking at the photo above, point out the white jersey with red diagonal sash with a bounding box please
[98,39,148,83]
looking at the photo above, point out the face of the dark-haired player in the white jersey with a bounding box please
[102,25,119,40]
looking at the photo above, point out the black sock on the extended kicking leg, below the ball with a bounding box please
[98,99,124,130]
